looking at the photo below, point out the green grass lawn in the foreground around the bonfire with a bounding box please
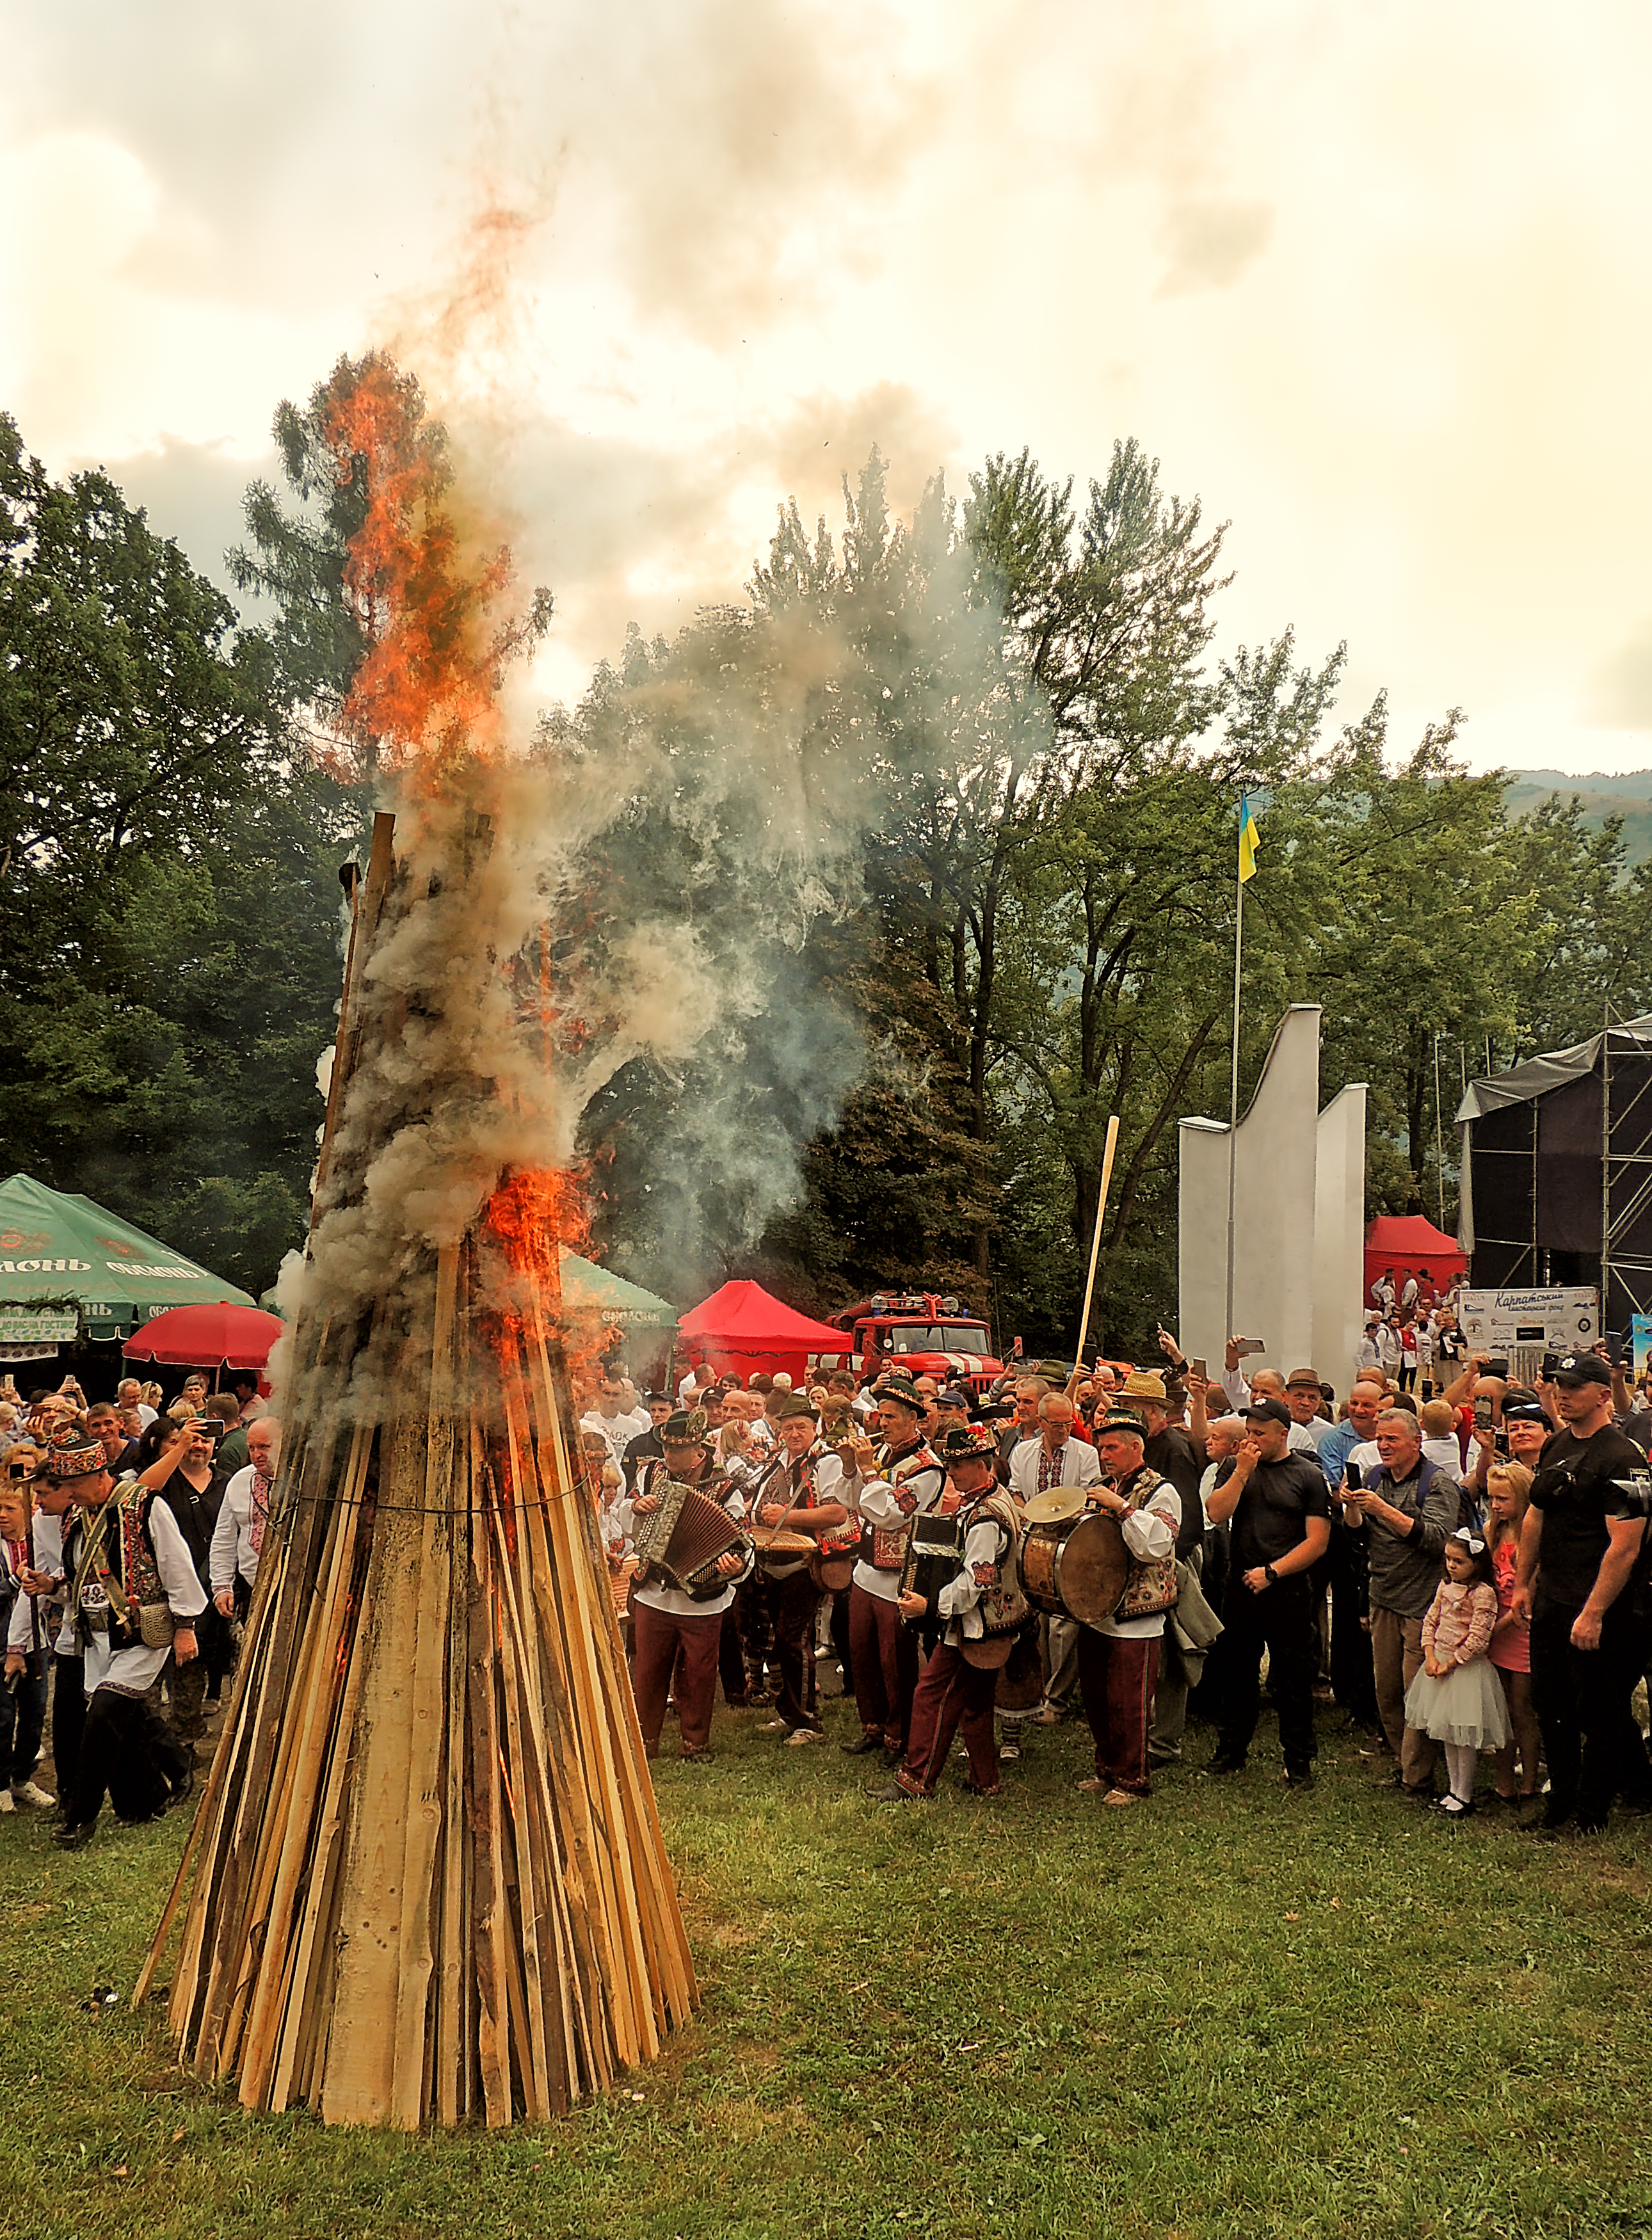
[0,1705,1652,2240]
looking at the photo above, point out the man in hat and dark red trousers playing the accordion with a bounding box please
[614,1409,753,1761]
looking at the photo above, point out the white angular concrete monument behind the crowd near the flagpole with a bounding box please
[1177,1004,1365,1393]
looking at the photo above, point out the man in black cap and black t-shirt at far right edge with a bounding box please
[1515,1353,1652,1832]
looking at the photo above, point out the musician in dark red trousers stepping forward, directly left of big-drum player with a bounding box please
[867,1425,1027,1804]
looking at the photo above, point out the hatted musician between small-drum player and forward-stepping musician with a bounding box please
[843,1378,946,1759]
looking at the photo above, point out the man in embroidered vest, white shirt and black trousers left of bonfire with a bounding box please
[40,1445,206,1850]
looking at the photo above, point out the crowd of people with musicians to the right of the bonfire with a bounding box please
[581,1299,1652,1835]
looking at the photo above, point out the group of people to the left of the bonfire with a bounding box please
[0,1375,280,1848]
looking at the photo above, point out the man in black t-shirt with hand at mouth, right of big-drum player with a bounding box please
[1206,1400,1331,1788]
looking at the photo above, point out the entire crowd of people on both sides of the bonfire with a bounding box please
[0,1299,1652,1848]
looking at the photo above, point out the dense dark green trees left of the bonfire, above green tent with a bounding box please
[0,419,358,1290]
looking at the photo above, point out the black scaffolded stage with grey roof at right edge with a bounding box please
[1457,1017,1652,1331]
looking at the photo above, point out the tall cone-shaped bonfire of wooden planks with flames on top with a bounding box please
[143,358,695,2128]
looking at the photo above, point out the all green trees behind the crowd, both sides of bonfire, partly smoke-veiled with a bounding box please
[0,370,1652,1353]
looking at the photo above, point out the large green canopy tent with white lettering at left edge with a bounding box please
[0,1174,253,1362]
